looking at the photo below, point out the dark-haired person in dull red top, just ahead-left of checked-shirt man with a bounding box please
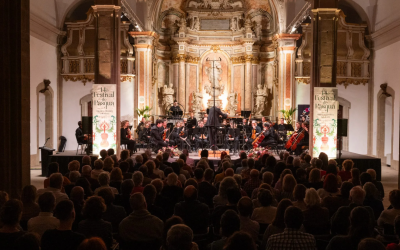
[251,189,276,224]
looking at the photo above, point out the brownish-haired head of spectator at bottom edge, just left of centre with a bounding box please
[167,224,193,250]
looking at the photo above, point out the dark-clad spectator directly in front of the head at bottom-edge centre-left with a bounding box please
[174,185,210,234]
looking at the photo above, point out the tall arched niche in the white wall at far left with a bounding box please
[36,82,54,161]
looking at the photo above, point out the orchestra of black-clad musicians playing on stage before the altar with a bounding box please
[125,109,309,155]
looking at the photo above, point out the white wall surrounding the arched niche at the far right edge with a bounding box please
[373,41,400,164]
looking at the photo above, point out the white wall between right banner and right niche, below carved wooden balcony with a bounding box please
[336,85,368,154]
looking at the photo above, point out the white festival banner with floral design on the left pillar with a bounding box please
[92,84,117,154]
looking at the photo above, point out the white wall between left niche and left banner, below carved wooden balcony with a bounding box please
[62,81,93,150]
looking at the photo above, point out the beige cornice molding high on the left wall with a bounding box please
[30,13,67,46]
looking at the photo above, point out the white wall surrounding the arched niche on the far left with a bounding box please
[30,36,58,158]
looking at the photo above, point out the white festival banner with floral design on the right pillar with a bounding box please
[312,87,338,159]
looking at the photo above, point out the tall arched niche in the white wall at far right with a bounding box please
[376,86,395,165]
